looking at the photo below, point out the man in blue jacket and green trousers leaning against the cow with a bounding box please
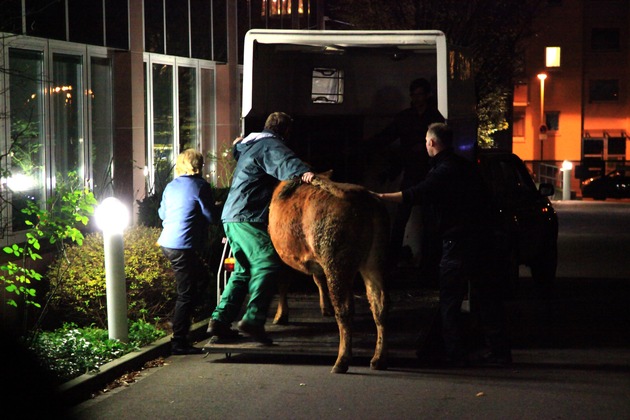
[208,112,315,344]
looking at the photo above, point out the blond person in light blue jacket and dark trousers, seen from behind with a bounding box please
[158,149,218,354]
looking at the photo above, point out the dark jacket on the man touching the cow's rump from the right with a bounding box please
[402,149,492,239]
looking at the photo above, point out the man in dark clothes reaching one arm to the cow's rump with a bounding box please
[378,123,511,365]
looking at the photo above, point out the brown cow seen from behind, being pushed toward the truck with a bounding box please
[269,176,389,373]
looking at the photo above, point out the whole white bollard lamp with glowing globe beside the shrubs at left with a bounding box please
[94,197,129,343]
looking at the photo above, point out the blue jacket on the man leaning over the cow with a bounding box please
[221,130,310,224]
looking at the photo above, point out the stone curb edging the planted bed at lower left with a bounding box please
[58,319,209,405]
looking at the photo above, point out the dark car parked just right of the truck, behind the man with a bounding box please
[477,151,558,287]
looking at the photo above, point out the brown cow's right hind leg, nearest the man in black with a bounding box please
[361,269,389,370]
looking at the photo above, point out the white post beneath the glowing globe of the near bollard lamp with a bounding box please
[103,230,129,343]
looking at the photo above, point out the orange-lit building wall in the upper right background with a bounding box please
[513,0,630,169]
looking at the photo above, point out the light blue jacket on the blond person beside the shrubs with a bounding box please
[158,175,216,249]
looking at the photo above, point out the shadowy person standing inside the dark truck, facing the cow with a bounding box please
[371,78,444,278]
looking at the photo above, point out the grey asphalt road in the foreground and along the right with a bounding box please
[66,201,630,420]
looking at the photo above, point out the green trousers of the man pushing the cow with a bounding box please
[212,222,282,325]
